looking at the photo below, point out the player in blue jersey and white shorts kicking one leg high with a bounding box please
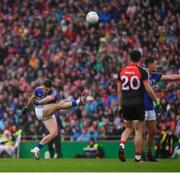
[23,80,87,159]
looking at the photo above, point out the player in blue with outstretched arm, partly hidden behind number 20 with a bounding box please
[142,57,180,161]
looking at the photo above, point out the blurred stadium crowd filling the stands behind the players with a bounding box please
[0,0,180,149]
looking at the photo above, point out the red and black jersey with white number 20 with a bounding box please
[119,64,148,105]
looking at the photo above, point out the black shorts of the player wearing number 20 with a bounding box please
[122,104,145,121]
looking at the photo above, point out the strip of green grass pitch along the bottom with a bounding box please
[0,159,180,172]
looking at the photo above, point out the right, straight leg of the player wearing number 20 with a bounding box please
[133,121,144,161]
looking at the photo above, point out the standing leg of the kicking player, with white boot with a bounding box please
[31,116,58,159]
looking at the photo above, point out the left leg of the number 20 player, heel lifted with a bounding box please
[119,122,133,162]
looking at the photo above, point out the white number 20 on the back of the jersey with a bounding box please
[121,75,141,90]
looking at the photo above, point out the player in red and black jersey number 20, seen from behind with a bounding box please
[118,50,159,161]
